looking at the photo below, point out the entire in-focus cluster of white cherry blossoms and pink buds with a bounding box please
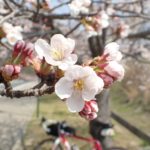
[0,34,124,120]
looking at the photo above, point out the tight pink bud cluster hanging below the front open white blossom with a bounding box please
[79,100,98,120]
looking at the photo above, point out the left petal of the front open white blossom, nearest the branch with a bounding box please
[55,77,73,99]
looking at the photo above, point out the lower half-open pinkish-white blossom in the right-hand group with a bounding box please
[104,61,124,81]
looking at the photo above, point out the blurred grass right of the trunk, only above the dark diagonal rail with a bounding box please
[111,84,150,135]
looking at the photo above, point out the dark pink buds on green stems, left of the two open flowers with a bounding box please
[0,41,34,82]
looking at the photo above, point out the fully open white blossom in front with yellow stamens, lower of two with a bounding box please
[55,65,104,112]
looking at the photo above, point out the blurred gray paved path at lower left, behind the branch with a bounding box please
[0,82,36,150]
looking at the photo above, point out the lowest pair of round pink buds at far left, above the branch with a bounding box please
[1,65,21,81]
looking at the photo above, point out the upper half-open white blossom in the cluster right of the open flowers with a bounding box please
[103,42,122,61]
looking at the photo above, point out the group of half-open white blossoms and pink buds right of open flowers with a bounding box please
[91,42,124,88]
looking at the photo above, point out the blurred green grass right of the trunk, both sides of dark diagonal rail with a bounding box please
[110,83,150,150]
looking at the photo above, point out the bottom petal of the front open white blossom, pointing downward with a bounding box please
[66,92,85,112]
